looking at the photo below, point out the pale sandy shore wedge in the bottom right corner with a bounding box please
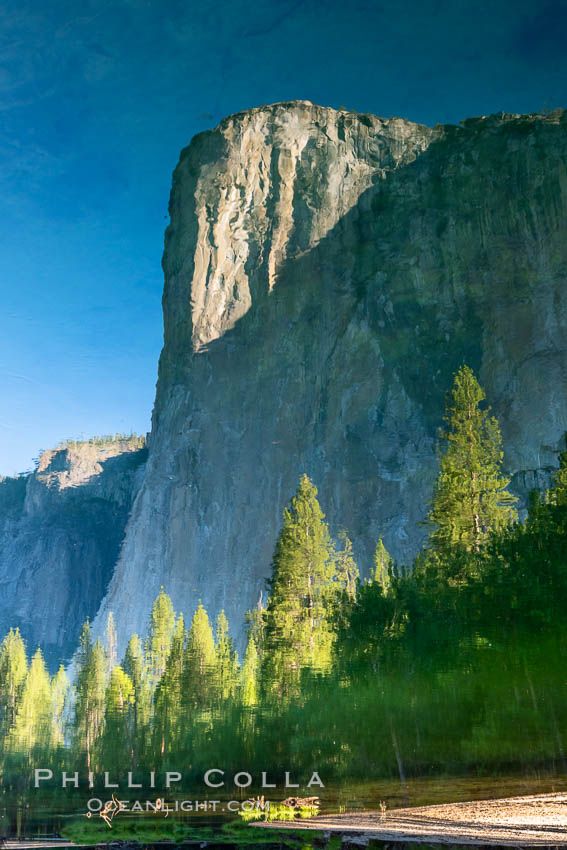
[255,793,567,847]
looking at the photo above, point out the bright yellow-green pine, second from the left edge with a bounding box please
[10,649,55,759]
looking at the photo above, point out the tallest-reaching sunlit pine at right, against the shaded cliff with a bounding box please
[429,366,517,559]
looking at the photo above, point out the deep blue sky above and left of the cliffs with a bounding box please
[0,0,567,474]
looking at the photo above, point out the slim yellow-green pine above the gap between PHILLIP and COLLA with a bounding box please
[183,602,217,708]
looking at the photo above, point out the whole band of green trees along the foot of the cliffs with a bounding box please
[0,366,567,787]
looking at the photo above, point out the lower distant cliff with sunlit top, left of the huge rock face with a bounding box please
[0,441,147,667]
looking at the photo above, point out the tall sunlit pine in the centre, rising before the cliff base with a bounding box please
[263,475,336,687]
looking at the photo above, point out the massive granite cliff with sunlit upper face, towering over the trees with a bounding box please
[93,102,567,640]
